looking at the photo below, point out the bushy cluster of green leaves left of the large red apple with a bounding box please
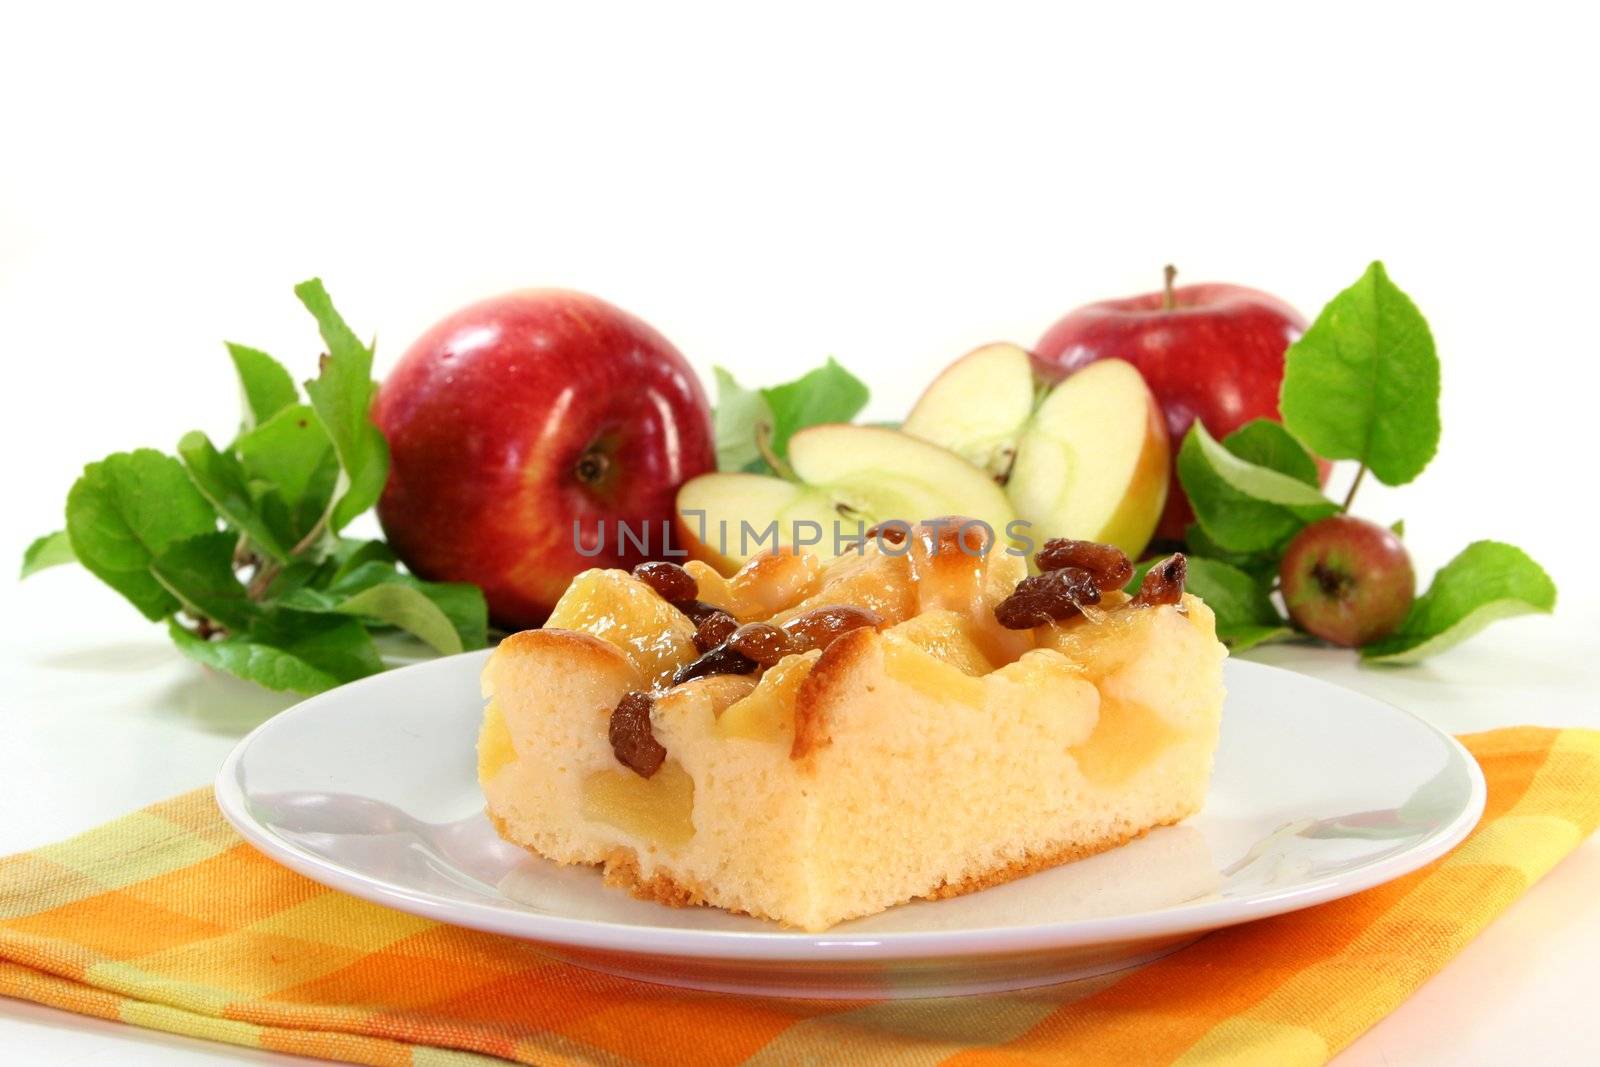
[22,278,488,693]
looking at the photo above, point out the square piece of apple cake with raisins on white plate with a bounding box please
[478,520,1226,929]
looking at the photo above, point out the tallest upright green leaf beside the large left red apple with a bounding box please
[294,278,389,533]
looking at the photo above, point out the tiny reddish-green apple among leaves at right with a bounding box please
[1278,515,1416,648]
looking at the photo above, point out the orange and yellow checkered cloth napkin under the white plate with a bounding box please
[0,728,1600,1067]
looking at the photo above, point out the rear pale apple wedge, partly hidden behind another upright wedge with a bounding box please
[901,344,1040,483]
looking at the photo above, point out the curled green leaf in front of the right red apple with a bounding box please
[1178,419,1339,553]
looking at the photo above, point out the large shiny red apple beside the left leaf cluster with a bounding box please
[374,290,717,629]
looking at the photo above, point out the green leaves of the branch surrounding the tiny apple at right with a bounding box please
[1178,262,1555,662]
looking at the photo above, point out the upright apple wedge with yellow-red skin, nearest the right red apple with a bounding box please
[1006,360,1171,560]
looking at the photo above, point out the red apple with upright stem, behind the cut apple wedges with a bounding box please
[1034,283,1326,541]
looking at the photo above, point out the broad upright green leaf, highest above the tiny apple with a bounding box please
[1278,261,1438,485]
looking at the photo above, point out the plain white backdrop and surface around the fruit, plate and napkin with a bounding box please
[0,2,1600,1064]
